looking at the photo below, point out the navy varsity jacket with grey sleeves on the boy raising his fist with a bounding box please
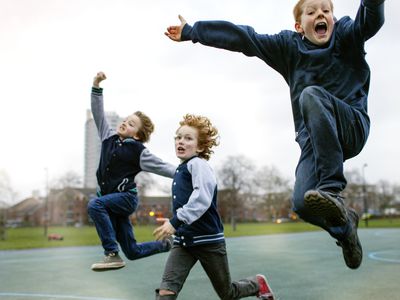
[91,87,176,195]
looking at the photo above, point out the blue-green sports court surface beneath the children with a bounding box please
[0,229,400,300]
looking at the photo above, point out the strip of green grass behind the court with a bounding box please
[0,218,400,250]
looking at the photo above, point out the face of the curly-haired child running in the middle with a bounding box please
[175,125,202,161]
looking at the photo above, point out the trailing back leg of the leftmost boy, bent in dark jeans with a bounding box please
[115,216,171,260]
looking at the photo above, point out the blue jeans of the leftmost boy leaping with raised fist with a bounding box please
[88,192,166,260]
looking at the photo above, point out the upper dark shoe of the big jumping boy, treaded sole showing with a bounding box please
[304,190,347,227]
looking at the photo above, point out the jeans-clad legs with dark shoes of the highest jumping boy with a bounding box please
[293,86,369,269]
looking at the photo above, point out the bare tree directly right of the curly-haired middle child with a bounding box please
[217,155,254,231]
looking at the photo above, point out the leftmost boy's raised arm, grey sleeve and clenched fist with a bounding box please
[91,72,114,141]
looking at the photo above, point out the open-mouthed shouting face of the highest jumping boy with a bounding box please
[295,0,334,46]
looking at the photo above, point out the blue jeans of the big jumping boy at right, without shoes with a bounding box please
[293,86,369,238]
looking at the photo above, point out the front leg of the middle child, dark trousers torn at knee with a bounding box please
[156,245,197,300]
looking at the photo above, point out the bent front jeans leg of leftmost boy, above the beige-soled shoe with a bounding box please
[88,193,136,255]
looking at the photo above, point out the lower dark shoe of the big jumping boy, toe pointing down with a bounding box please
[336,208,362,269]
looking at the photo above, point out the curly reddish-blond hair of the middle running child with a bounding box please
[179,114,219,160]
